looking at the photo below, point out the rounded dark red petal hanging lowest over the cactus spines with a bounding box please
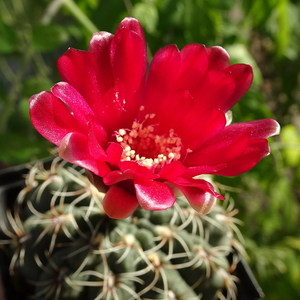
[103,185,138,219]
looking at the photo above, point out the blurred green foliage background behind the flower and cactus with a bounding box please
[0,0,300,300]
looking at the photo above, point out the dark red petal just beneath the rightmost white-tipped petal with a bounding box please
[216,140,270,176]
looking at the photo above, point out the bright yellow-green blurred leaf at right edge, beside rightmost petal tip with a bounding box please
[280,124,300,167]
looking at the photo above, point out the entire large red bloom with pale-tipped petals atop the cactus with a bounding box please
[30,18,279,218]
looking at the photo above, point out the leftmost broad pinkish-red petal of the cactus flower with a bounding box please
[29,92,81,146]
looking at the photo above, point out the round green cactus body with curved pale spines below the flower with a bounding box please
[0,158,242,300]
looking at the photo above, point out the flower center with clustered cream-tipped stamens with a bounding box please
[115,115,182,170]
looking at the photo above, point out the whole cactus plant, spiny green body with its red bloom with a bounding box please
[0,18,279,300]
